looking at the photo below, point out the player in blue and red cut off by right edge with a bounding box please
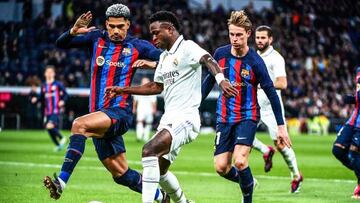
[332,67,360,199]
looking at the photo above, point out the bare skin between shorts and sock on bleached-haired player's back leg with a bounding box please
[101,152,128,177]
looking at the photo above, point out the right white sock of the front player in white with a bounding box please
[160,171,186,203]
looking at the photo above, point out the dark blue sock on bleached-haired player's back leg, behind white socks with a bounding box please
[113,168,160,200]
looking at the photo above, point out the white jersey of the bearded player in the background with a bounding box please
[257,46,286,114]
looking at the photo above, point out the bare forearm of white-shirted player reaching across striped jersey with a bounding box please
[105,82,164,99]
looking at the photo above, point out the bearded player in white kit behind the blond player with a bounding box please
[253,25,303,193]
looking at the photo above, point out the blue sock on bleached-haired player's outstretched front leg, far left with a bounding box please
[59,134,86,183]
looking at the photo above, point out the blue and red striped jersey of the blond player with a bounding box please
[202,45,283,124]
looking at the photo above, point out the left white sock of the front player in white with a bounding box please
[141,156,160,203]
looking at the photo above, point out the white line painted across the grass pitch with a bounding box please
[0,161,356,184]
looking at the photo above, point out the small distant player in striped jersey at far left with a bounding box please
[31,65,68,151]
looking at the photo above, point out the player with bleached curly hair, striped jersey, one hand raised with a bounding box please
[44,4,169,200]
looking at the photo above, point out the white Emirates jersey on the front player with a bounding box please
[154,35,208,121]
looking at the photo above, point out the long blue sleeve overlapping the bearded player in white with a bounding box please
[254,57,284,125]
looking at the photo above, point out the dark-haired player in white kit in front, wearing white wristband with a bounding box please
[106,11,237,203]
